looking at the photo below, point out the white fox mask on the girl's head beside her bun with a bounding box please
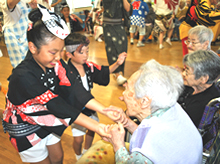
[38,4,70,39]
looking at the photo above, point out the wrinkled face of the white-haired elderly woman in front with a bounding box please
[123,71,140,116]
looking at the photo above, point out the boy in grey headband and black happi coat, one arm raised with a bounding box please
[65,33,127,159]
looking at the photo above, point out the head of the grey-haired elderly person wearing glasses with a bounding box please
[185,25,213,53]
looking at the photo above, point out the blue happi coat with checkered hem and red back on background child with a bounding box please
[130,0,149,27]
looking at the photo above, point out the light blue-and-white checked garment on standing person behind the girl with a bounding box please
[4,2,30,68]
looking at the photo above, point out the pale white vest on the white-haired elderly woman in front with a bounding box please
[130,104,202,164]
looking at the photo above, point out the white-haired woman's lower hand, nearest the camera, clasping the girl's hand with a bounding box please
[107,123,125,152]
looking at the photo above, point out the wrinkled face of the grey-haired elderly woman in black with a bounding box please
[182,65,200,87]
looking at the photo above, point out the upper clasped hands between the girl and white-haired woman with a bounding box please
[103,106,128,125]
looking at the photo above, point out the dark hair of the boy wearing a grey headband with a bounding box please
[65,32,90,54]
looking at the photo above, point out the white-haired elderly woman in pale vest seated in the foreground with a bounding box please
[106,60,202,164]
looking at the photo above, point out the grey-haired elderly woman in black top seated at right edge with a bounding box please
[178,50,220,127]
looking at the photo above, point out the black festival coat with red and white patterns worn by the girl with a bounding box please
[3,52,93,152]
